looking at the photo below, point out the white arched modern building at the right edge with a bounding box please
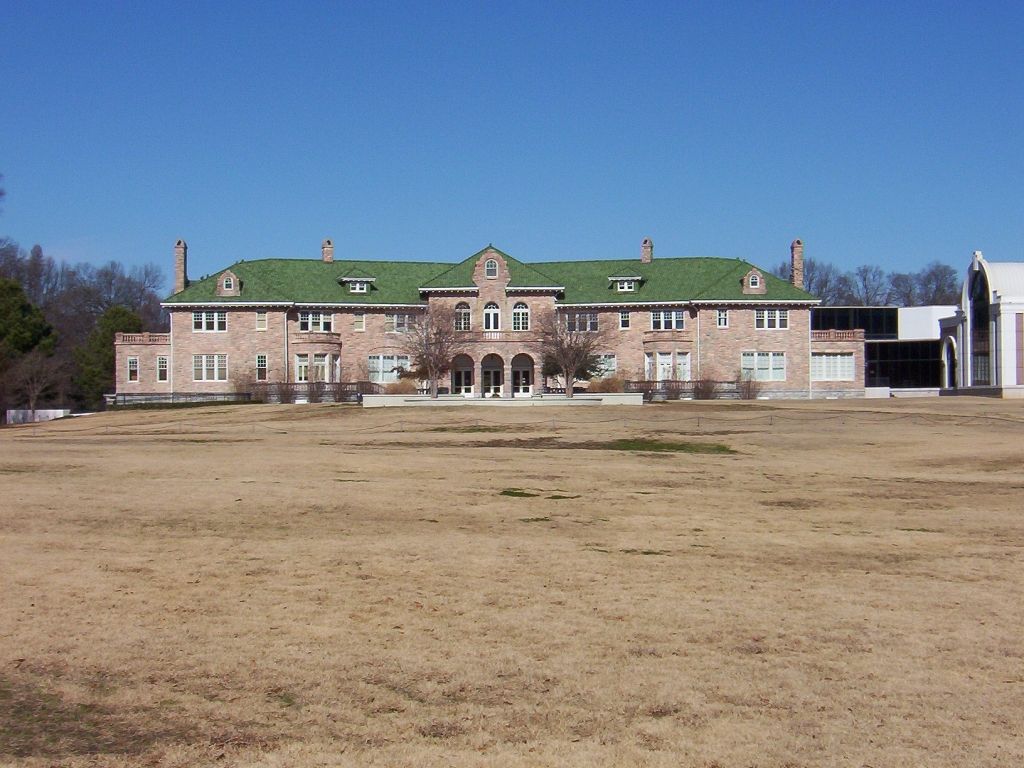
[939,251,1024,397]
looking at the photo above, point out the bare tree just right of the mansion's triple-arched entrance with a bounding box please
[535,310,608,397]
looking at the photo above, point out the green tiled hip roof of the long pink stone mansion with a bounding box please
[167,251,815,305]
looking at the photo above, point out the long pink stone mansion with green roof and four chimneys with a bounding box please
[116,239,864,400]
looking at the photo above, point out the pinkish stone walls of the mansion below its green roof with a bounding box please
[117,246,863,397]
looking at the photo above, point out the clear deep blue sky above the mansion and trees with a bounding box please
[0,0,1024,290]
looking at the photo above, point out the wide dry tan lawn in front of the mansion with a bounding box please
[0,398,1024,768]
